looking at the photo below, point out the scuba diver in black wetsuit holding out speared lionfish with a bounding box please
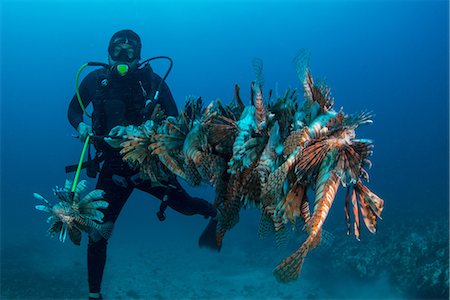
[68,30,219,299]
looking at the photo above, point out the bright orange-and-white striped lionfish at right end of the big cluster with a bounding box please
[268,52,384,282]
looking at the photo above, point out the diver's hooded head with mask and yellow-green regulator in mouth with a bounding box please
[108,29,142,77]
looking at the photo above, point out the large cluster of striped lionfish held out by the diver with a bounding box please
[118,51,384,282]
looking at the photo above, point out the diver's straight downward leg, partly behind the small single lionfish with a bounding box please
[88,162,133,293]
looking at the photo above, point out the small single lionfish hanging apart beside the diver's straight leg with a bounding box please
[33,180,113,245]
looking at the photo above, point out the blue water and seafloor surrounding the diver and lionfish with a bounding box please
[0,0,449,299]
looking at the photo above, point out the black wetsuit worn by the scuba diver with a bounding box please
[68,66,216,293]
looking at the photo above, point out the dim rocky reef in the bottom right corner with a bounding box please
[330,217,449,299]
